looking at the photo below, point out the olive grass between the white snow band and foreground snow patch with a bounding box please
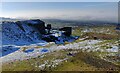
[2,50,67,71]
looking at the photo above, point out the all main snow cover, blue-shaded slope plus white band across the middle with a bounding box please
[0,20,119,63]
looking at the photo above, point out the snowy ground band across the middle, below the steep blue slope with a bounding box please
[0,32,119,63]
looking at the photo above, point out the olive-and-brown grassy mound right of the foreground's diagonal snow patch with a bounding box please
[55,52,119,71]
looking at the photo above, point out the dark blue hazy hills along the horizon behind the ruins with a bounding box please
[42,19,117,27]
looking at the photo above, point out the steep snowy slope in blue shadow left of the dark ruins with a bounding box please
[2,20,45,45]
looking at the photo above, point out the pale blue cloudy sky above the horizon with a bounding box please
[0,2,118,22]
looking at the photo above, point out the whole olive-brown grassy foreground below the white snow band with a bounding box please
[2,44,119,71]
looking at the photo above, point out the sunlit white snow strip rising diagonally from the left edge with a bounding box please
[0,40,102,63]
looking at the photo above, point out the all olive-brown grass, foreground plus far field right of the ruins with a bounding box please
[2,26,120,71]
